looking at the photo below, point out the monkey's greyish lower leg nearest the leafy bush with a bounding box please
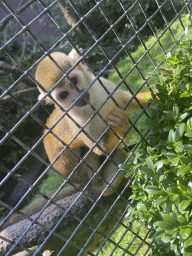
[95,149,127,196]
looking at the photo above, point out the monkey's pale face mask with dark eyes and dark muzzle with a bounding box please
[51,70,90,109]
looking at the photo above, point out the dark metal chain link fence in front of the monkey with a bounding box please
[0,0,191,256]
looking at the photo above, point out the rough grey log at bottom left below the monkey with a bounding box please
[0,192,92,253]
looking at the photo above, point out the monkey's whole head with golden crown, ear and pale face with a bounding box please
[36,52,91,112]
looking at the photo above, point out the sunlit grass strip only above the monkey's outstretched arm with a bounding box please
[108,15,189,89]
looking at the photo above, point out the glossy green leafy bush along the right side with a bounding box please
[121,20,192,256]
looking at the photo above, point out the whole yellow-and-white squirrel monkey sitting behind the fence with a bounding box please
[36,50,151,196]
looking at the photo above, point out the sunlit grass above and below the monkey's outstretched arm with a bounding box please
[108,15,189,145]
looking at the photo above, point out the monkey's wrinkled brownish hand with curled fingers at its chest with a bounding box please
[106,107,128,135]
